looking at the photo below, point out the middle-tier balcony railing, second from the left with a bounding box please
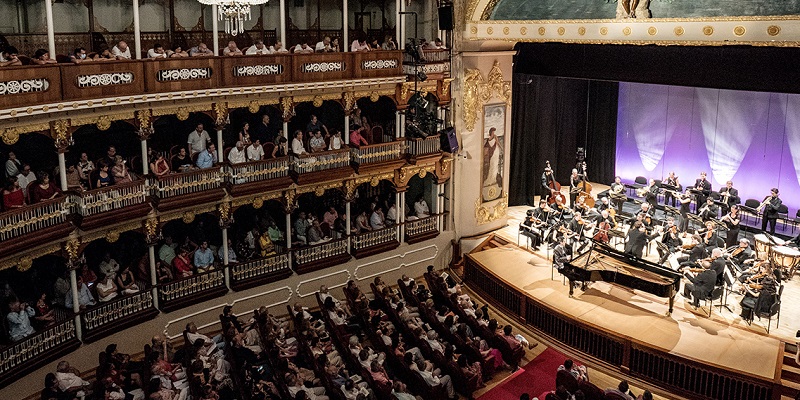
[74,180,148,217]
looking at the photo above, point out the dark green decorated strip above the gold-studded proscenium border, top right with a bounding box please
[486,0,800,20]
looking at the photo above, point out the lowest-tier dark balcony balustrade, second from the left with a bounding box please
[81,289,158,342]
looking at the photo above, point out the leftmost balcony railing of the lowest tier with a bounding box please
[0,318,77,375]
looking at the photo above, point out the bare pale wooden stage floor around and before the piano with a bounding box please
[473,247,782,379]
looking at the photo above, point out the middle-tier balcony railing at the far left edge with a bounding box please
[0,196,73,240]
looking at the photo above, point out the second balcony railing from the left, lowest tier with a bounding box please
[81,290,155,336]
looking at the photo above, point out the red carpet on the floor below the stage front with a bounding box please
[478,348,567,400]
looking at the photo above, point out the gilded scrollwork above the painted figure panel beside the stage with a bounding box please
[462,60,511,132]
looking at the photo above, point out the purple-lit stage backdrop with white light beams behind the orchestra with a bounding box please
[616,82,800,217]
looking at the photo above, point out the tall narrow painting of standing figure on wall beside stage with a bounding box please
[481,104,506,202]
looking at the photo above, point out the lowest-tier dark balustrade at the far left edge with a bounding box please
[0,318,79,382]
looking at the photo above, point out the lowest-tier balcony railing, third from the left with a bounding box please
[158,269,228,311]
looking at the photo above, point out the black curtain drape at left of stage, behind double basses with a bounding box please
[509,74,618,205]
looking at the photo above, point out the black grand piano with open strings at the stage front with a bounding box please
[563,242,682,315]
